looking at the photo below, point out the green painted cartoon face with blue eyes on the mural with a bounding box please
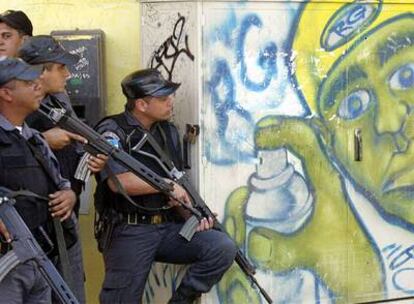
[318,14,414,223]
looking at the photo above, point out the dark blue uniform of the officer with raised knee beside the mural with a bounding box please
[97,112,236,304]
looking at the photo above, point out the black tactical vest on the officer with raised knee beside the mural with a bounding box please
[95,113,183,214]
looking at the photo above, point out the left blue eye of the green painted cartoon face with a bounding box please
[338,90,371,119]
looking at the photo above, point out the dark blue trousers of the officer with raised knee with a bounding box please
[100,223,237,304]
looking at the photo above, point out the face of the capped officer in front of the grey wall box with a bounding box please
[40,63,70,94]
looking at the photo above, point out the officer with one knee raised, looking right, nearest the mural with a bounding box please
[95,69,236,303]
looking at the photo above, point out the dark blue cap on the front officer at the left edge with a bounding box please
[0,57,41,87]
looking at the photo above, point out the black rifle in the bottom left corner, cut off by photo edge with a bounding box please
[0,187,79,304]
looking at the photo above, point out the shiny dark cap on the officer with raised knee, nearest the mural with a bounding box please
[121,69,180,99]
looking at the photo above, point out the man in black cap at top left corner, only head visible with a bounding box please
[0,10,33,57]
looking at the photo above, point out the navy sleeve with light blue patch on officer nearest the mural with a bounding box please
[96,119,129,180]
